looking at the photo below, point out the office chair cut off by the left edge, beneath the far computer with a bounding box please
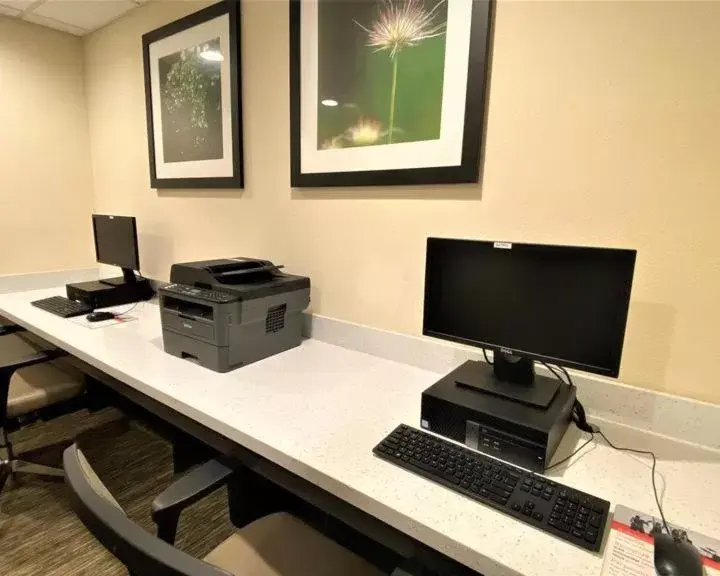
[0,317,85,492]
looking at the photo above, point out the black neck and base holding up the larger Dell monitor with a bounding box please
[455,352,560,409]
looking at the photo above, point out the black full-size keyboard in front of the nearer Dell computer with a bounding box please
[373,424,610,552]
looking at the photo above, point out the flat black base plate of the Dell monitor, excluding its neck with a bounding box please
[455,354,560,409]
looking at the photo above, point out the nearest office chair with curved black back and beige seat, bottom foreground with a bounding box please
[63,445,382,576]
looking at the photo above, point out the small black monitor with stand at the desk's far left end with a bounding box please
[93,214,140,285]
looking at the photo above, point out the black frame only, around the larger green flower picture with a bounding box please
[290,0,494,188]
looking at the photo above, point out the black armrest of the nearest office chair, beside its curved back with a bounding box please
[152,459,239,544]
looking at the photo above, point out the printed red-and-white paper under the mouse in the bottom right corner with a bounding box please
[601,506,720,576]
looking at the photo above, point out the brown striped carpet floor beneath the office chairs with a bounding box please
[0,409,233,576]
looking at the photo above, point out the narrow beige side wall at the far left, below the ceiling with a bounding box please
[0,16,94,274]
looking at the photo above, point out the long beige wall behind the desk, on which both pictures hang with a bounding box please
[85,0,720,402]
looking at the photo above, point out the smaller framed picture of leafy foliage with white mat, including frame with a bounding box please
[142,0,243,188]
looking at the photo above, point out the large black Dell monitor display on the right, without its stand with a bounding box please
[423,238,636,376]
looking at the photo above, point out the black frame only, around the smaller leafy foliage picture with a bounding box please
[142,0,244,189]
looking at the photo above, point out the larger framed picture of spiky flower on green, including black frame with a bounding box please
[290,0,491,187]
